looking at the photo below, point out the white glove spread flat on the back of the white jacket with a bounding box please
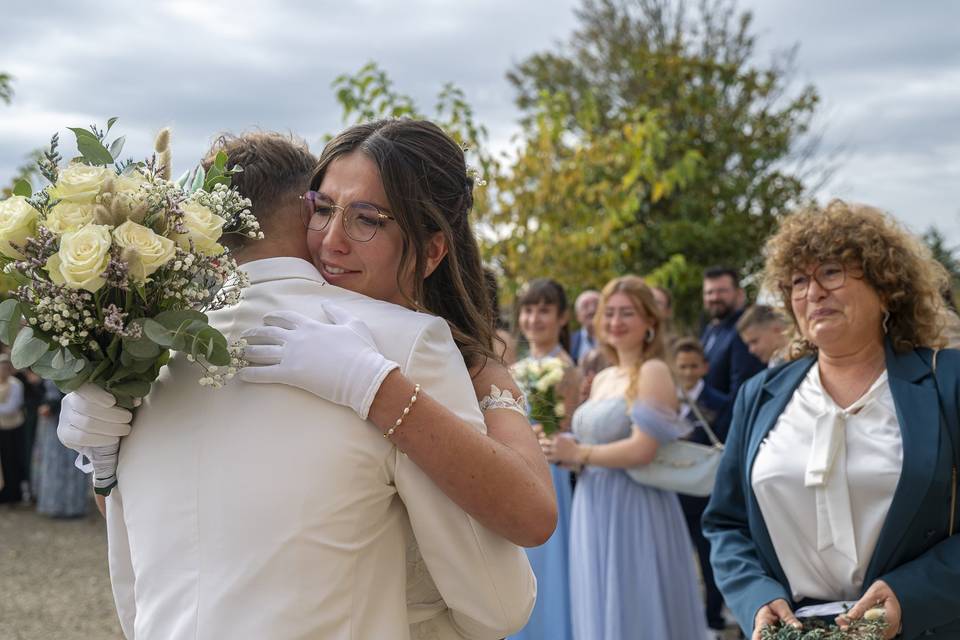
[239,303,399,420]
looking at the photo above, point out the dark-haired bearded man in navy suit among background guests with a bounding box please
[700,267,764,399]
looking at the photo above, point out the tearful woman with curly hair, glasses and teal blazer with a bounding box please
[704,201,960,638]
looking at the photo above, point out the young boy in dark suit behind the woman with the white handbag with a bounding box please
[673,338,730,637]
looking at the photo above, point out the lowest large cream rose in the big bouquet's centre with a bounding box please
[47,224,110,293]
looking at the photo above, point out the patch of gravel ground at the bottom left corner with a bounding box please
[0,501,123,640]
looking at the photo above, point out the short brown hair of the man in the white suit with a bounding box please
[203,131,317,245]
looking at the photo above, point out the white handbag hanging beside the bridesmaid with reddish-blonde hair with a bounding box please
[626,393,723,498]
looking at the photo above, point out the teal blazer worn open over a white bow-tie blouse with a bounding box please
[703,343,960,640]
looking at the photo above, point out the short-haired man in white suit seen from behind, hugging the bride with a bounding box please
[61,133,536,640]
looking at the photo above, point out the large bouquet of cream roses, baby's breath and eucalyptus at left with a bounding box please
[0,118,262,408]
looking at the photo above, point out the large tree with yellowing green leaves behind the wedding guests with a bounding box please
[498,0,818,326]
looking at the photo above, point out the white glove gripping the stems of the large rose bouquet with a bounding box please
[57,383,133,495]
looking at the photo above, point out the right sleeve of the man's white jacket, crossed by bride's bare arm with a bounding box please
[395,318,536,640]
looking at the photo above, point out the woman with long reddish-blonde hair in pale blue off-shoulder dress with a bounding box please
[543,276,704,640]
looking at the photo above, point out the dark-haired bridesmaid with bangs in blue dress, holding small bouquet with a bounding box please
[512,278,586,640]
